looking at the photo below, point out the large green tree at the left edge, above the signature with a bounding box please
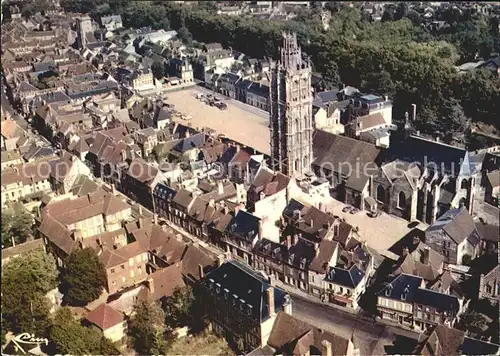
[2,250,58,335]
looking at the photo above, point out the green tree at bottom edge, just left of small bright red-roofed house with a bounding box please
[50,307,120,355]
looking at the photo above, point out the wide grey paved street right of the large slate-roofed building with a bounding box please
[292,295,419,356]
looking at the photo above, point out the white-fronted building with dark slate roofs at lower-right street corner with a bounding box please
[377,273,463,330]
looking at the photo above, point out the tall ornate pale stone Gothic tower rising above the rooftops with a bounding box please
[269,33,313,176]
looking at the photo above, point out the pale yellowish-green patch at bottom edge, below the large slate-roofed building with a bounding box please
[166,332,234,355]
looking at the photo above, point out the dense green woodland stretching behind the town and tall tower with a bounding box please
[56,0,500,135]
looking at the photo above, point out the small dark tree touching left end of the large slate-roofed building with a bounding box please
[162,286,194,329]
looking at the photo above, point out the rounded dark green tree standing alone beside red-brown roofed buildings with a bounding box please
[62,248,106,306]
